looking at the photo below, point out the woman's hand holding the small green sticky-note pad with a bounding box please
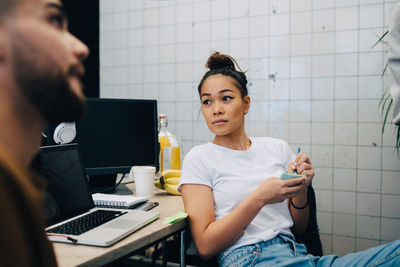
[252,177,307,205]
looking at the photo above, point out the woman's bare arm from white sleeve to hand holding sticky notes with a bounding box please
[181,177,305,259]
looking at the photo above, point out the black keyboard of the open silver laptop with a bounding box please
[46,210,126,235]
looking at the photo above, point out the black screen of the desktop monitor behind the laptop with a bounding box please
[74,98,159,175]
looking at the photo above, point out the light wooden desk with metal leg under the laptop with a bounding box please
[53,188,188,267]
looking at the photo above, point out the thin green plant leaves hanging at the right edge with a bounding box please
[372,30,400,152]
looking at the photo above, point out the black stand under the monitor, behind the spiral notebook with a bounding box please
[89,174,132,195]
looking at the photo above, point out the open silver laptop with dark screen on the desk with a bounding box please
[32,144,160,247]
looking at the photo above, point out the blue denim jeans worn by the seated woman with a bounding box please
[218,234,400,267]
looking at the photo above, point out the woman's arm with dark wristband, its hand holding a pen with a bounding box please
[288,153,314,235]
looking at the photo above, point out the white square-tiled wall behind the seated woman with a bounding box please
[100,0,400,254]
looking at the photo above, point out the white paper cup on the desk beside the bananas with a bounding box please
[129,166,156,198]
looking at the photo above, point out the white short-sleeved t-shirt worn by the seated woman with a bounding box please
[179,137,295,254]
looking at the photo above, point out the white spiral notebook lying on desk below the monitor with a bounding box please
[92,193,149,209]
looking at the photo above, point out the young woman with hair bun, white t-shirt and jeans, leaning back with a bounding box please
[179,52,400,266]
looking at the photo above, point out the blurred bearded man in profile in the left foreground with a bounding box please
[0,0,88,266]
